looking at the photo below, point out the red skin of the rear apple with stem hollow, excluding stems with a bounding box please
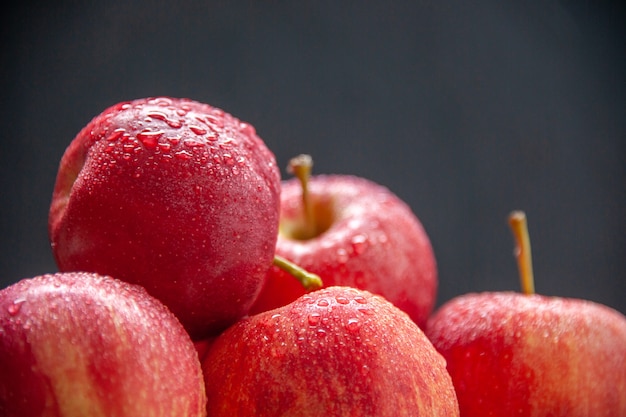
[247,175,438,326]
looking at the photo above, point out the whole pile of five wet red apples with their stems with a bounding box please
[0,97,626,417]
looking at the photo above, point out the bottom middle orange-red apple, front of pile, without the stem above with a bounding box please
[203,287,459,417]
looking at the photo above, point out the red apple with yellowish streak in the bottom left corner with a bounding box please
[0,273,206,417]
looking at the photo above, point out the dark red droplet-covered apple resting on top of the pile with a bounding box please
[49,97,280,339]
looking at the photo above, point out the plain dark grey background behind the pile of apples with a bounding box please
[0,0,626,313]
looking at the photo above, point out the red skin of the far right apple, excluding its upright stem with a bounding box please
[426,292,626,417]
